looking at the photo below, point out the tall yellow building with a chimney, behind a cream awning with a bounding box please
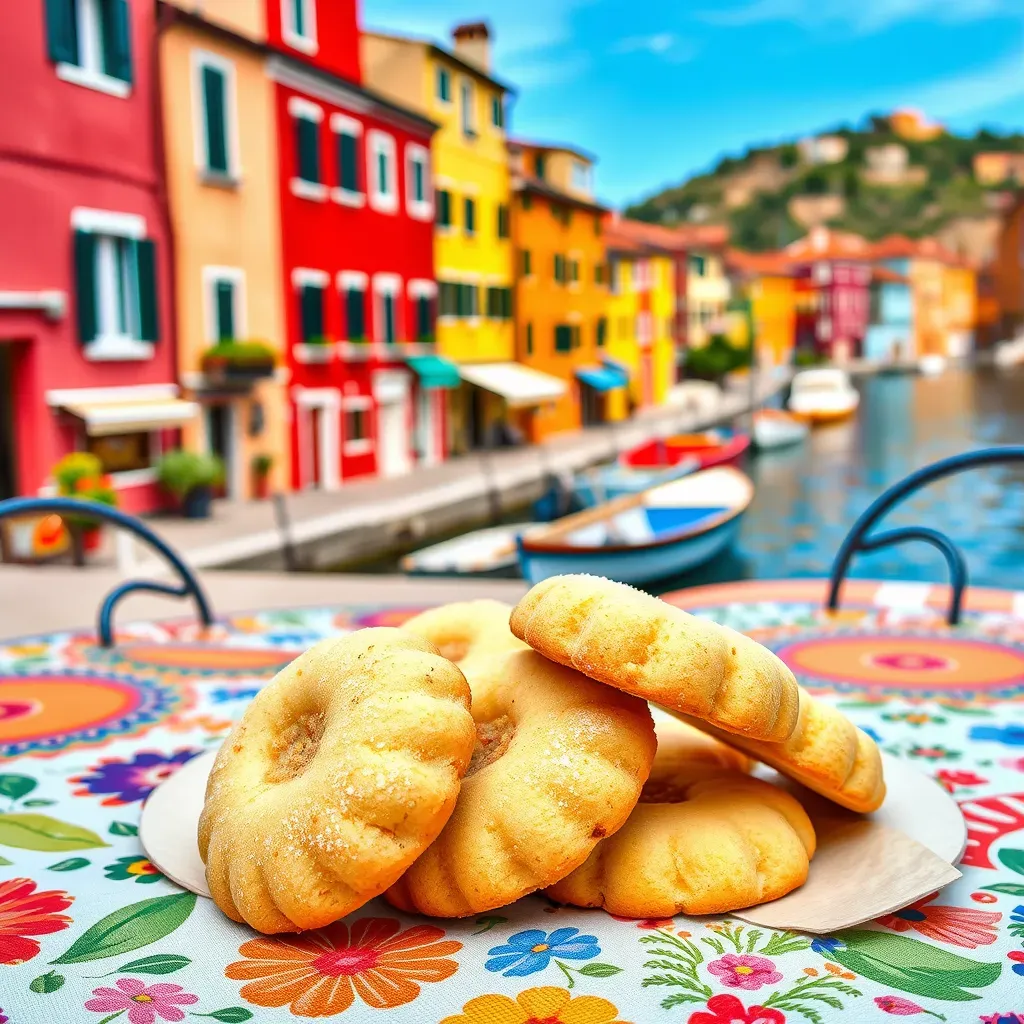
[360,24,515,453]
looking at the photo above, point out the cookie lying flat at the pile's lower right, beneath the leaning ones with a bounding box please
[546,774,815,918]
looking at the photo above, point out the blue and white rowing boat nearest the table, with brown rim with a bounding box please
[517,466,754,584]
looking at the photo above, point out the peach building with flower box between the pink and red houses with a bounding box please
[159,0,291,499]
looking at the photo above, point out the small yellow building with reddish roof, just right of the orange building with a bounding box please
[605,217,686,409]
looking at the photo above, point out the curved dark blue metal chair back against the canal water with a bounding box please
[825,444,1024,626]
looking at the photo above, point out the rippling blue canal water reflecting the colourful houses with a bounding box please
[359,369,1024,594]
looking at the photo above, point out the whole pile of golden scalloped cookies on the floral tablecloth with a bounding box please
[199,575,885,933]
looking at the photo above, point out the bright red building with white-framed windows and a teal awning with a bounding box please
[267,0,442,489]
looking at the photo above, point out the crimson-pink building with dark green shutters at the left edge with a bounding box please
[0,0,186,511]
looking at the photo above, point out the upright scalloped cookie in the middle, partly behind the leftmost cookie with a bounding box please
[385,650,654,918]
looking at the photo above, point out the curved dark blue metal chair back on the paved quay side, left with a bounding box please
[0,498,213,647]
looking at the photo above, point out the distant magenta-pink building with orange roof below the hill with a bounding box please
[783,227,872,361]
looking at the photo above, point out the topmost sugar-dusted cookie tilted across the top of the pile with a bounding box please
[510,575,798,742]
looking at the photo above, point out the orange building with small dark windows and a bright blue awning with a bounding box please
[509,141,610,442]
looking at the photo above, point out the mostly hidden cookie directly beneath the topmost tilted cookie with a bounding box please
[675,688,886,814]
